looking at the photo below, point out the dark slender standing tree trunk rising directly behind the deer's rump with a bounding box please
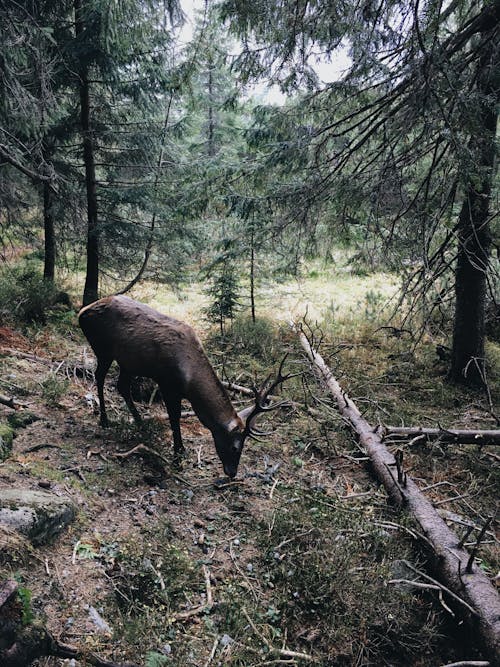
[74,0,99,306]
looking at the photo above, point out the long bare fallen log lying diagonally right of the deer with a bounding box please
[299,332,500,665]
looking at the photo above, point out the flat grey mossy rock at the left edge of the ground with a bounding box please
[0,489,75,545]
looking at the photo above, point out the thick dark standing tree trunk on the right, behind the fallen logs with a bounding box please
[449,11,500,386]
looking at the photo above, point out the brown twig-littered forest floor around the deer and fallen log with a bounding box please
[0,274,500,667]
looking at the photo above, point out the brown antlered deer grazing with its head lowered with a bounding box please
[78,295,291,479]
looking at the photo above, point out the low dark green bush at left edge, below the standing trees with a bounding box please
[0,265,59,324]
